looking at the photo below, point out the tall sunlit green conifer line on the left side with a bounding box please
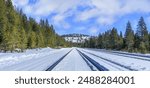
[0,0,67,52]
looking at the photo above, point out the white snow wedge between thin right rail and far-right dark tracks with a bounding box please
[81,49,150,71]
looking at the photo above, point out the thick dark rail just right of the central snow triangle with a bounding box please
[77,50,108,71]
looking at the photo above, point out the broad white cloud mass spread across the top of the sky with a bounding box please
[13,0,150,33]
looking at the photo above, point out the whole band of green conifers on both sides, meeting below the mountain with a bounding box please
[0,0,150,53]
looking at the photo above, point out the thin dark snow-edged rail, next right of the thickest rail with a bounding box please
[82,50,137,71]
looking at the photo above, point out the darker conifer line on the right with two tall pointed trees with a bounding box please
[83,17,150,53]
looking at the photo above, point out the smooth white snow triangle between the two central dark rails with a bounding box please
[53,49,91,71]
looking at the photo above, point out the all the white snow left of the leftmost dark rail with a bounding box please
[0,48,70,71]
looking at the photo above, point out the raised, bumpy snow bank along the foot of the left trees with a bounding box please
[0,47,57,68]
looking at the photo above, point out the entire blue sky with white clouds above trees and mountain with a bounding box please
[12,0,150,36]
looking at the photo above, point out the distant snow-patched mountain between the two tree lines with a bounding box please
[62,34,91,43]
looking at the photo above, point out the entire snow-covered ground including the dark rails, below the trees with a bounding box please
[0,48,150,71]
